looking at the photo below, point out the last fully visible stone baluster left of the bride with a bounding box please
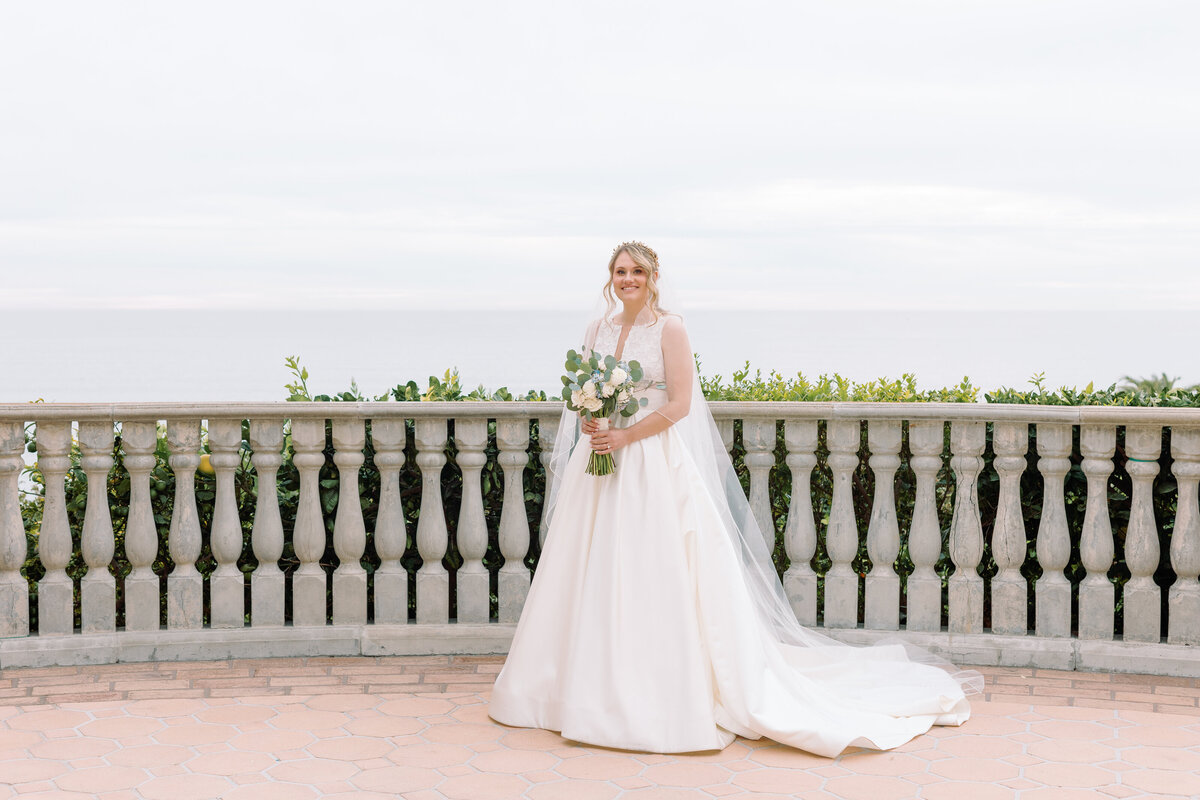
[496,420,532,622]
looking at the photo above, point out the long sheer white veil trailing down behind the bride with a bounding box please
[546,278,983,694]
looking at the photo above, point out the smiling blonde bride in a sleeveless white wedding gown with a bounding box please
[490,242,982,757]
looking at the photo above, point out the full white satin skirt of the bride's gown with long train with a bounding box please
[490,412,970,757]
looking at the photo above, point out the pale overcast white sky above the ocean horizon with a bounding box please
[0,0,1200,309]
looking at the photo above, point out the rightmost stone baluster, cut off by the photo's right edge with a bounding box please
[1166,427,1200,644]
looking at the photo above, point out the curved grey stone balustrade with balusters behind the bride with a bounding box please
[0,402,1200,675]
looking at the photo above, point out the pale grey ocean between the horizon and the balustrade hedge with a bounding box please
[0,309,1200,403]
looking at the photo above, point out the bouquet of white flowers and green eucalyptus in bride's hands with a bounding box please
[563,350,647,475]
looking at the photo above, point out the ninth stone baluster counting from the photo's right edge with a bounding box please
[824,420,862,627]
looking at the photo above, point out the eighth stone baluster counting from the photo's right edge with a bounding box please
[863,420,901,631]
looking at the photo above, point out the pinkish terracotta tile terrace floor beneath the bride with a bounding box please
[0,656,1200,800]
